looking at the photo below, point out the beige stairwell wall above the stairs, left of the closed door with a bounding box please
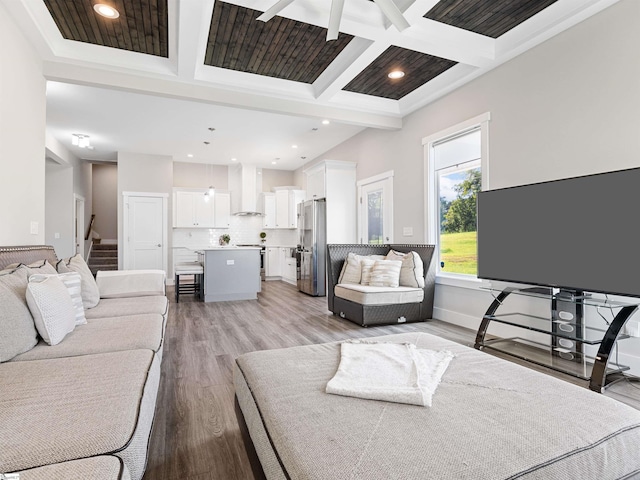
[91,163,118,241]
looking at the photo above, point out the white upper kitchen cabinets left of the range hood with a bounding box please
[173,189,231,228]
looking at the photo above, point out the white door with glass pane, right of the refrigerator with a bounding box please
[358,174,393,244]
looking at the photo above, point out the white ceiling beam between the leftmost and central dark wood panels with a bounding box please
[175,0,215,80]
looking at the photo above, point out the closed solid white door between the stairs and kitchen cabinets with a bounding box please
[124,195,167,271]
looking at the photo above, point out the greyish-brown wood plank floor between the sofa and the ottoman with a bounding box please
[144,281,640,480]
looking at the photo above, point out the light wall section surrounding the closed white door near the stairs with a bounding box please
[118,152,173,269]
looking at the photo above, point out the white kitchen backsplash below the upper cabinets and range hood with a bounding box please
[173,216,298,248]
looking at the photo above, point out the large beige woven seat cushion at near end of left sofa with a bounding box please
[0,350,159,478]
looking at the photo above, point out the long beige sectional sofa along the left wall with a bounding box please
[0,246,168,480]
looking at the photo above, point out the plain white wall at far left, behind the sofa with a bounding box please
[0,4,46,245]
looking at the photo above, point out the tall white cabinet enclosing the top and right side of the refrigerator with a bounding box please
[304,160,357,243]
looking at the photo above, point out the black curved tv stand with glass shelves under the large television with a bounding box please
[475,287,638,393]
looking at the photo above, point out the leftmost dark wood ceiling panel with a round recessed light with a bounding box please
[44,0,169,57]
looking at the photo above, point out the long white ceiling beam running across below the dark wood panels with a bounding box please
[43,62,402,129]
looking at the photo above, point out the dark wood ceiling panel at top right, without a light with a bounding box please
[425,0,557,38]
